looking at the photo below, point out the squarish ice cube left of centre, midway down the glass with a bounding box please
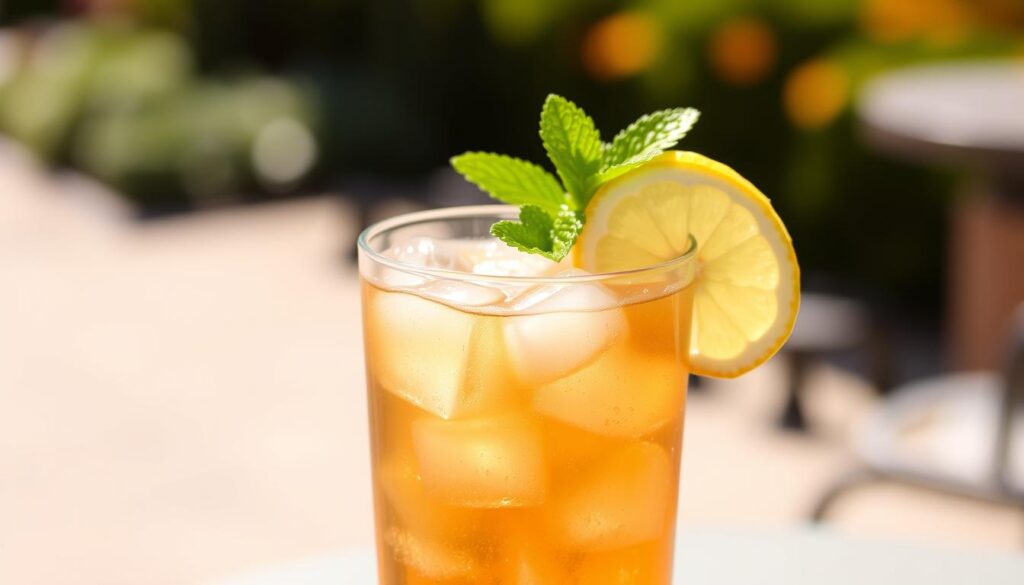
[413,414,547,508]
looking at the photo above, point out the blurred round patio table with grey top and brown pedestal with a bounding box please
[858,61,1024,369]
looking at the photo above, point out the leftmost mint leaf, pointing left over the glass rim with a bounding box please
[452,153,568,215]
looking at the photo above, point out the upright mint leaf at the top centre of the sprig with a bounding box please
[541,93,604,210]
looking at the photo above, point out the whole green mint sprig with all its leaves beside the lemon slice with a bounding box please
[452,94,699,261]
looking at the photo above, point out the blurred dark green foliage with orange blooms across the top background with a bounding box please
[0,0,1024,302]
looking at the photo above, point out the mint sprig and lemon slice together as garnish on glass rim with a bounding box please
[452,95,800,378]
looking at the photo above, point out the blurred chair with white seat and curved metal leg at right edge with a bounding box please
[812,304,1024,521]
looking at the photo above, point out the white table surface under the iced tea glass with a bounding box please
[211,528,1024,585]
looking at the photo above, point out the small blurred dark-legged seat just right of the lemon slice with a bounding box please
[778,293,891,431]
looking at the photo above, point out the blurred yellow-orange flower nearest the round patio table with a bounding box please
[782,58,850,129]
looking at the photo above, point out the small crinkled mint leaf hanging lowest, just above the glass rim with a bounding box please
[490,205,583,262]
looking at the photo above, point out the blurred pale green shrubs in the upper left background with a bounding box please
[0,22,314,213]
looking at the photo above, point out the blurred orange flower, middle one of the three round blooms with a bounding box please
[708,17,777,85]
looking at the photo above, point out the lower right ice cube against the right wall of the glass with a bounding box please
[545,442,676,552]
